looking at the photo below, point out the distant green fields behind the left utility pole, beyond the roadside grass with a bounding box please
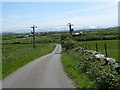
[2,34,60,44]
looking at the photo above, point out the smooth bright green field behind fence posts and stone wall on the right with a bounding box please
[79,40,120,61]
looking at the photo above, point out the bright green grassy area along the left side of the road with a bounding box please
[2,44,55,78]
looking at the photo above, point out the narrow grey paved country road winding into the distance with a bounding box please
[2,44,75,88]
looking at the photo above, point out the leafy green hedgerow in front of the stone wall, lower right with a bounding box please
[76,52,120,89]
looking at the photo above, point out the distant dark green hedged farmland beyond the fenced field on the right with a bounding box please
[74,29,120,41]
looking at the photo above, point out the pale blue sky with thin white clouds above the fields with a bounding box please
[2,2,118,32]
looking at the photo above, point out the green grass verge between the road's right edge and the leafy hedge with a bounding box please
[62,52,95,88]
